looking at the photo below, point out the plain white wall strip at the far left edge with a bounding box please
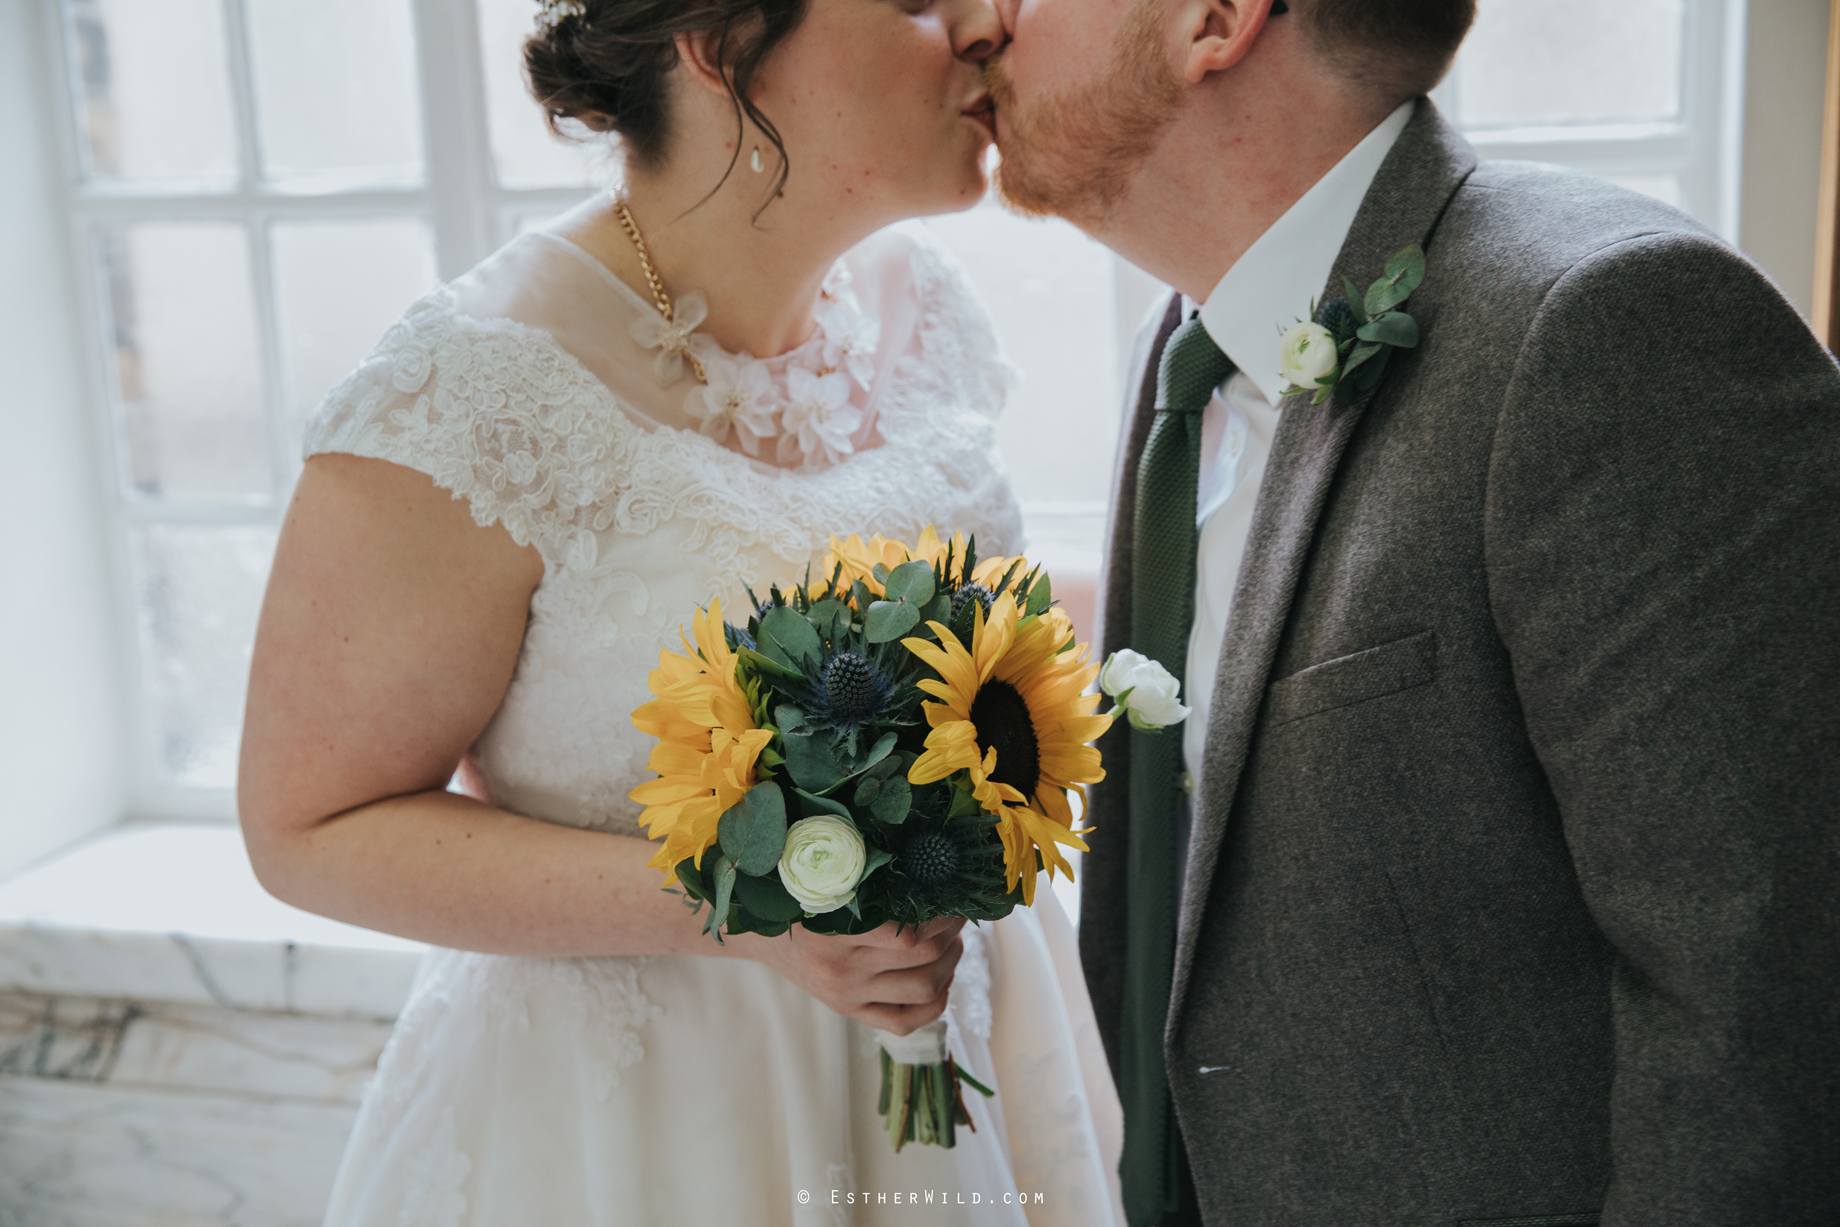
[0,0,123,874]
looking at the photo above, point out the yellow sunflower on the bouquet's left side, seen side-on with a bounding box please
[627,602,773,874]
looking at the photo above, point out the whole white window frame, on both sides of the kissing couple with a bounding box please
[37,0,1746,820]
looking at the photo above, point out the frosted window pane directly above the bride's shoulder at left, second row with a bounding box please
[270,217,434,462]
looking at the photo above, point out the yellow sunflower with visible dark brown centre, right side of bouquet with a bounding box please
[902,592,1111,903]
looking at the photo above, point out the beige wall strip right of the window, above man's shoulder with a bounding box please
[1739,0,1829,316]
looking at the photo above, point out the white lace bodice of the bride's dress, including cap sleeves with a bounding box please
[305,224,1021,835]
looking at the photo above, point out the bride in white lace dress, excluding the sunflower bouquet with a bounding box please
[239,0,1122,1227]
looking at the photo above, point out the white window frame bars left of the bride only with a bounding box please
[39,0,587,820]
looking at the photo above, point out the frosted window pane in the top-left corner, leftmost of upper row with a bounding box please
[64,0,237,188]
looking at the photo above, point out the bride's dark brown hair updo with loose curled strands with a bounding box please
[524,0,806,201]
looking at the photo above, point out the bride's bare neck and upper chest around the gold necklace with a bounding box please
[585,151,872,357]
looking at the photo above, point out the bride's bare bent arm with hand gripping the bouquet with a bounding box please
[237,454,960,1032]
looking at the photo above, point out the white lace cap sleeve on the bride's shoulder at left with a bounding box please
[304,291,637,563]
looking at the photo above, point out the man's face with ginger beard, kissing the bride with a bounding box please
[984,0,1185,224]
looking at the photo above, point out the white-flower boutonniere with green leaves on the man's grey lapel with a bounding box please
[1277,243,1424,405]
